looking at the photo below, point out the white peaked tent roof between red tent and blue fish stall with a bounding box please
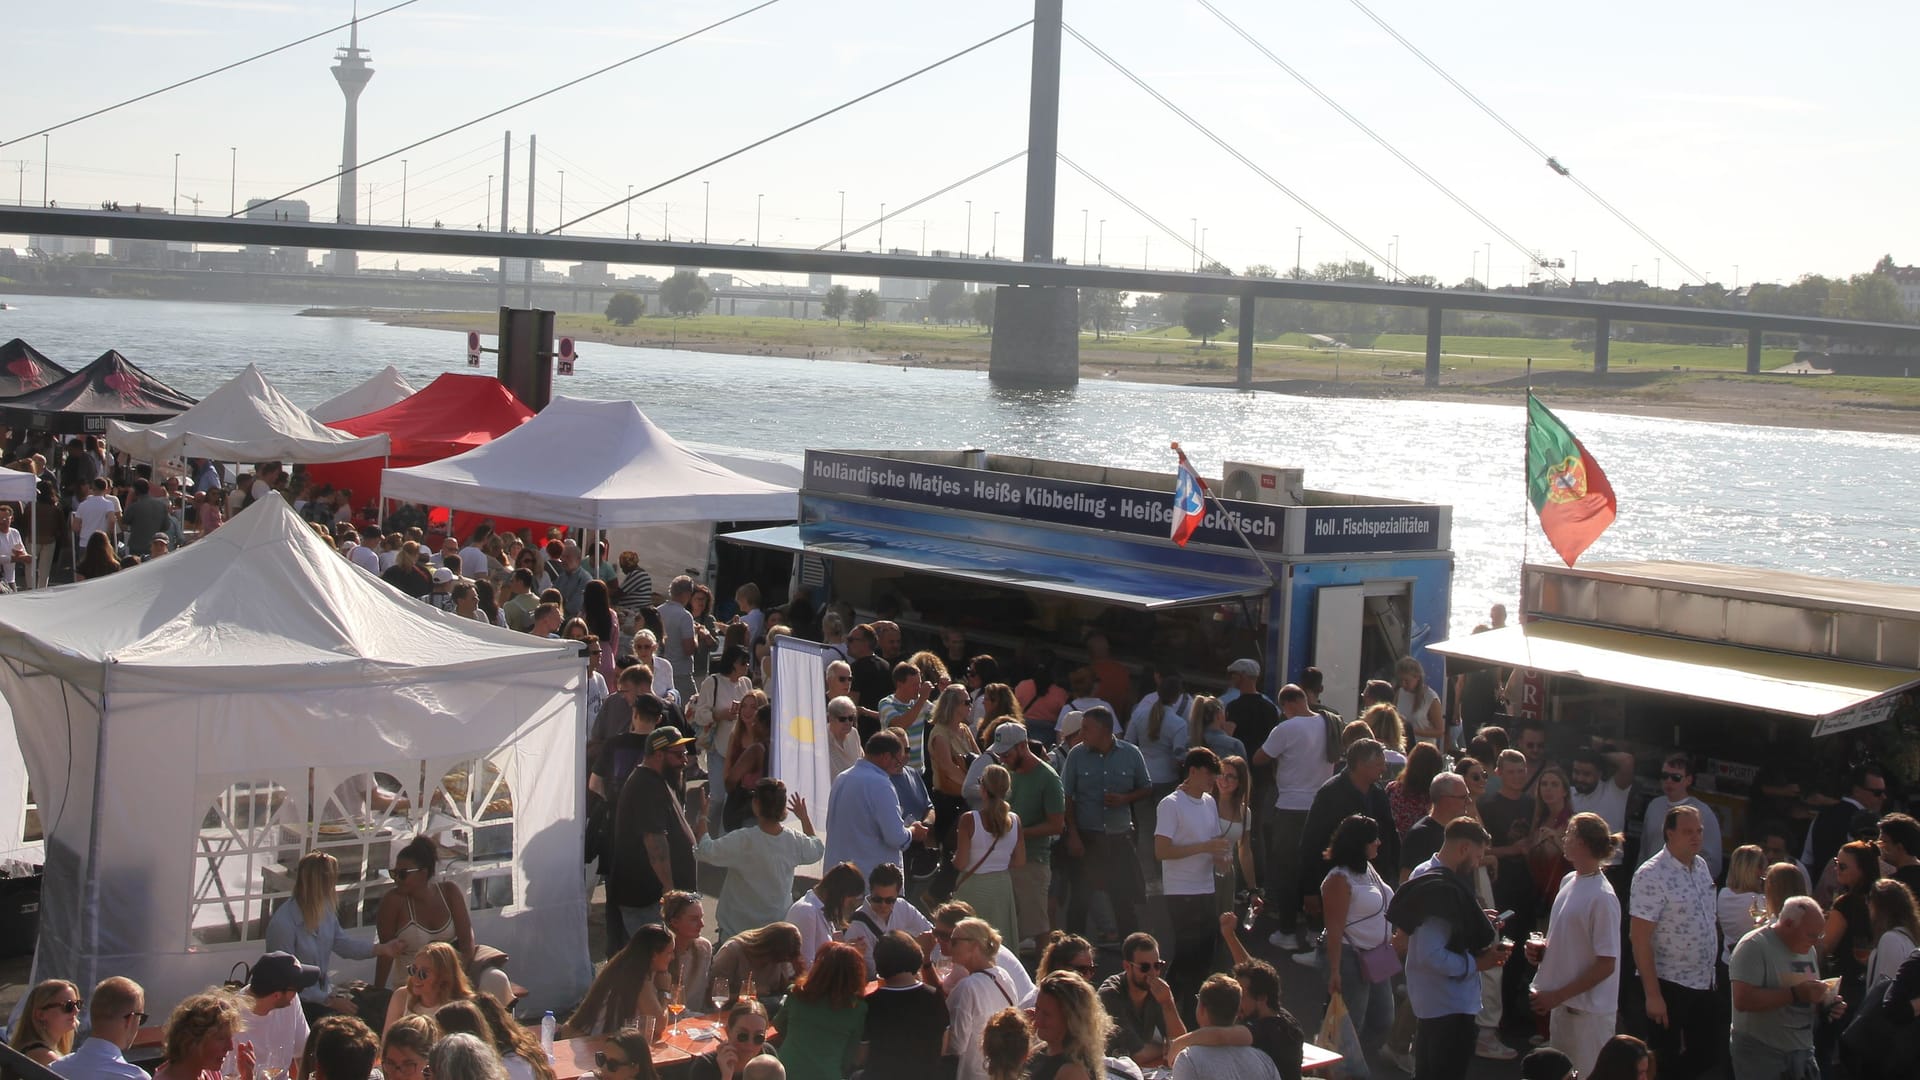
[382,396,801,582]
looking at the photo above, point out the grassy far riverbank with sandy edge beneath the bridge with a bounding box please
[303,307,1920,434]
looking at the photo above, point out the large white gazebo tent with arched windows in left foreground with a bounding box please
[0,496,591,1013]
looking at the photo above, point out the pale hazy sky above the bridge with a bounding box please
[0,0,1920,286]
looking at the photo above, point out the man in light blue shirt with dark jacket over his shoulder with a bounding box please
[1388,817,1513,1080]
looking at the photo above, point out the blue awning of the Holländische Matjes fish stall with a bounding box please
[724,523,1273,611]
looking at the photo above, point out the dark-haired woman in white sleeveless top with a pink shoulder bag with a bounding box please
[1321,813,1400,1078]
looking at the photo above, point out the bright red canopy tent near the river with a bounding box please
[307,371,534,505]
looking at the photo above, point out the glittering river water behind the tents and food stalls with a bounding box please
[0,292,1920,634]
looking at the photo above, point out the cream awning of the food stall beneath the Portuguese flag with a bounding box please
[1428,621,1920,734]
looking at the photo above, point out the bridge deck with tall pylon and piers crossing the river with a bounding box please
[0,0,1920,386]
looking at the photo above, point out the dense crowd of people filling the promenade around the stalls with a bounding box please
[0,440,1920,1080]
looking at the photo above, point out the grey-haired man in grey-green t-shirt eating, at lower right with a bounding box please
[1726,896,1847,1076]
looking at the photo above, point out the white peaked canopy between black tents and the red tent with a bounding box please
[106,363,390,465]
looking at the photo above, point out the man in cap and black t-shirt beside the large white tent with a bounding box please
[607,728,707,933]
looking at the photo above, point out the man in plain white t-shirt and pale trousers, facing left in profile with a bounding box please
[1526,813,1620,1076]
